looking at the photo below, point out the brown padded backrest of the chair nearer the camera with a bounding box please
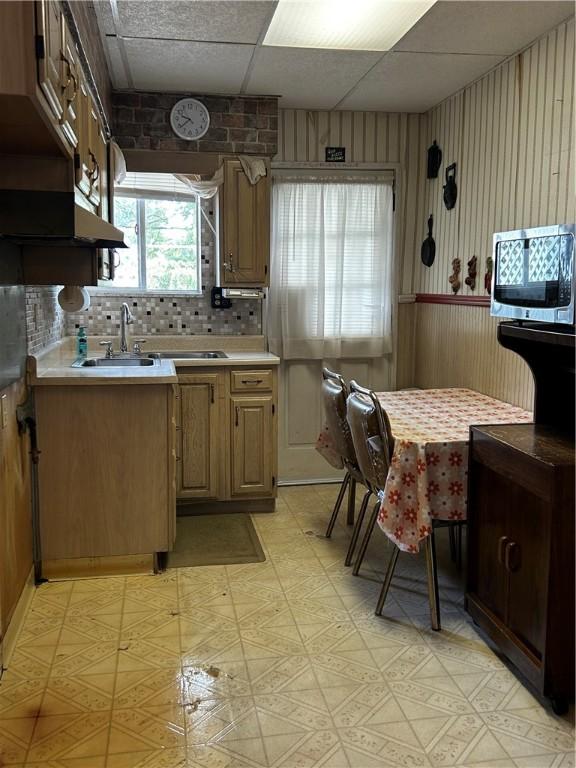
[347,381,394,491]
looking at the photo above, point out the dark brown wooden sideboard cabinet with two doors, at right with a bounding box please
[466,424,574,713]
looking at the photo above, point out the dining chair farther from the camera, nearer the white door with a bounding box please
[322,368,362,538]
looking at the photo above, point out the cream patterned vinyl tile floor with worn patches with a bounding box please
[0,485,574,768]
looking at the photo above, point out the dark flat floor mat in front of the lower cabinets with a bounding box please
[168,512,266,568]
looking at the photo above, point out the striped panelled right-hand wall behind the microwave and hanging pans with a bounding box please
[412,19,576,407]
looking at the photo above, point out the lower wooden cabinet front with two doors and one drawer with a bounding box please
[177,367,278,501]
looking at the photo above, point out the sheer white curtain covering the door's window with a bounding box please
[268,176,393,360]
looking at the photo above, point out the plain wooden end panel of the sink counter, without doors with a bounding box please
[35,384,176,560]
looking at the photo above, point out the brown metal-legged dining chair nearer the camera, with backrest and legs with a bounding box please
[346,381,394,576]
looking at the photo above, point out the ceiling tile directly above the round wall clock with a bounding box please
[124,39,254,93]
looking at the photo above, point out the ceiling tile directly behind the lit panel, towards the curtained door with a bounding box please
[246,46,382,109]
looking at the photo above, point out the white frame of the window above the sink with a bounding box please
[89,187,203,297]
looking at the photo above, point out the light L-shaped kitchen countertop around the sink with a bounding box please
[28,336,280,386]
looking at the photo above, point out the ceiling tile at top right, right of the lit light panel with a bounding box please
[394,0,574,55]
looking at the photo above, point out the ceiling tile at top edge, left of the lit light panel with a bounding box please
[118,0,275,43]
